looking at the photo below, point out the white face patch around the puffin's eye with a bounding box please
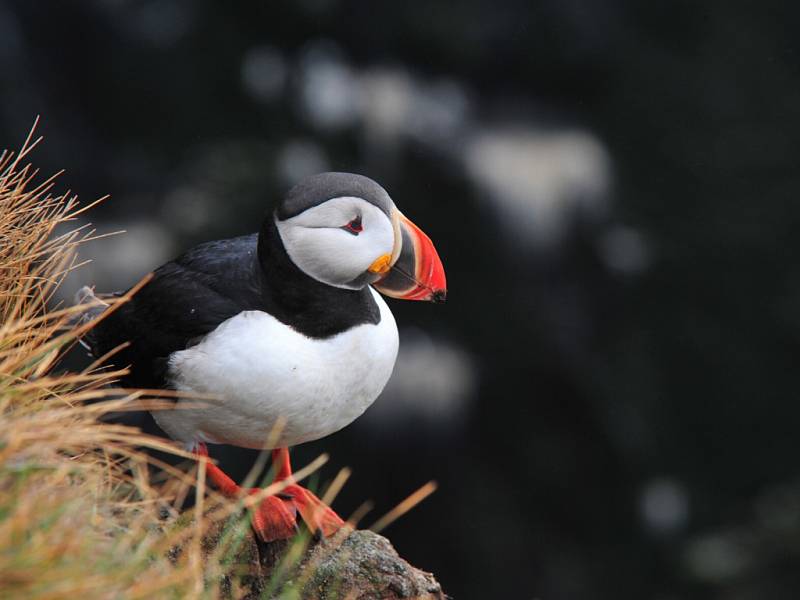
[275,196,395,289]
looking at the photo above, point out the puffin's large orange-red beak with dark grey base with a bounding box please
[372,211,447,302]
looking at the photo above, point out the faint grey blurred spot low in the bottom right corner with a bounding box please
[684,534,753,583]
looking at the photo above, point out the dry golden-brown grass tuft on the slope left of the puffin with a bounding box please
[0,127,274,599]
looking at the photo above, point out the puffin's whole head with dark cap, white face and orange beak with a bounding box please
[275,173,447,302]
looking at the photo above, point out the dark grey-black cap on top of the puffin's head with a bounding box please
[275,173,392,221]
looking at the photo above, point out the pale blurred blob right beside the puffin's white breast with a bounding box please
[360,329,478,433]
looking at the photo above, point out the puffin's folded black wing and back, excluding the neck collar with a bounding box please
[89,234,263,388]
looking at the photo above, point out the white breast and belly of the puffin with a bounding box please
[153,289,398,448]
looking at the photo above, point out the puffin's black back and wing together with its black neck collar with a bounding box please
[89,215,380,388]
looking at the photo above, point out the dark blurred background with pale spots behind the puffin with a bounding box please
[0,0,800,600]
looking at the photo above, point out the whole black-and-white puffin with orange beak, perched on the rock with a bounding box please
[77,173,447,542]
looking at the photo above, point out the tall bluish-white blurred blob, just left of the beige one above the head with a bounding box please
[300,41,360,130]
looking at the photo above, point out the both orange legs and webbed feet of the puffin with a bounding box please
[196,443,344,542]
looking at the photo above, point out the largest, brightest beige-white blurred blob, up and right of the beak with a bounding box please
[464,125,611,245]
